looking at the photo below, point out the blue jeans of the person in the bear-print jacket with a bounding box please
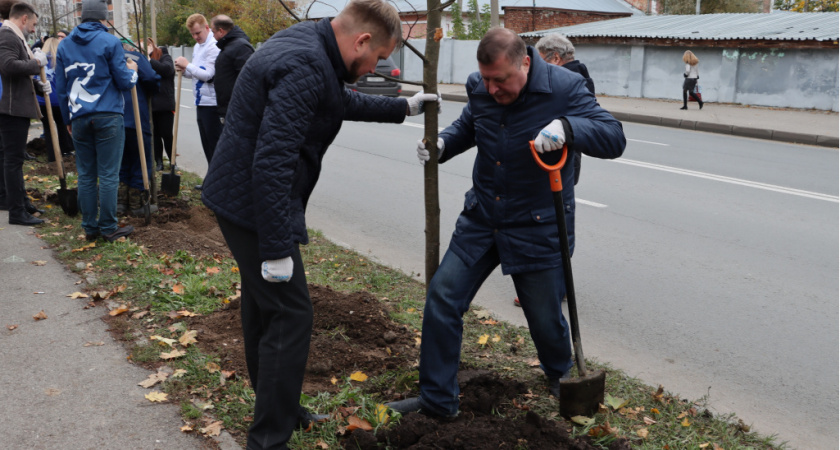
[72,113,125,234]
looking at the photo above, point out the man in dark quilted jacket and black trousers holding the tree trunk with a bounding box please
[202,0,437,449]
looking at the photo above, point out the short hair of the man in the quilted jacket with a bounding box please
[336,0,402,46]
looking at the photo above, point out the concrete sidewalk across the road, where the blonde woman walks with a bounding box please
[403,84,840,148]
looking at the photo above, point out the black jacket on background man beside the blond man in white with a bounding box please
[213,26,254,116]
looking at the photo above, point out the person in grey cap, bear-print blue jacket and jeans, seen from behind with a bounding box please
[55,0,137,242]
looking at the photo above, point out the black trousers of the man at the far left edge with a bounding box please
[0,114,29,218]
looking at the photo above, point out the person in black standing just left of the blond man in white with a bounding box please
[148,38,175,170]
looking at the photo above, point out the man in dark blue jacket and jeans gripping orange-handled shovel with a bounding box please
[389,28,626,417]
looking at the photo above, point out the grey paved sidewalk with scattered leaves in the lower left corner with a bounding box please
[0,127,239,449]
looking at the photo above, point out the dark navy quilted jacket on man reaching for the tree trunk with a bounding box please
[201,20,407,260]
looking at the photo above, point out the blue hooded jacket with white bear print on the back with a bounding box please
[55,22,137,124]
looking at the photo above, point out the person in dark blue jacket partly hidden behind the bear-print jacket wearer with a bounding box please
[117,39,160,215]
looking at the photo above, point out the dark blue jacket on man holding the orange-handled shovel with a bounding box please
[439,47,627,275]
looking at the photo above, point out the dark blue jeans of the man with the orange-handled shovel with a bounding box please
[420,246,573,416]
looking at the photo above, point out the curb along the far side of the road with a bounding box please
[402,88,840,148]
